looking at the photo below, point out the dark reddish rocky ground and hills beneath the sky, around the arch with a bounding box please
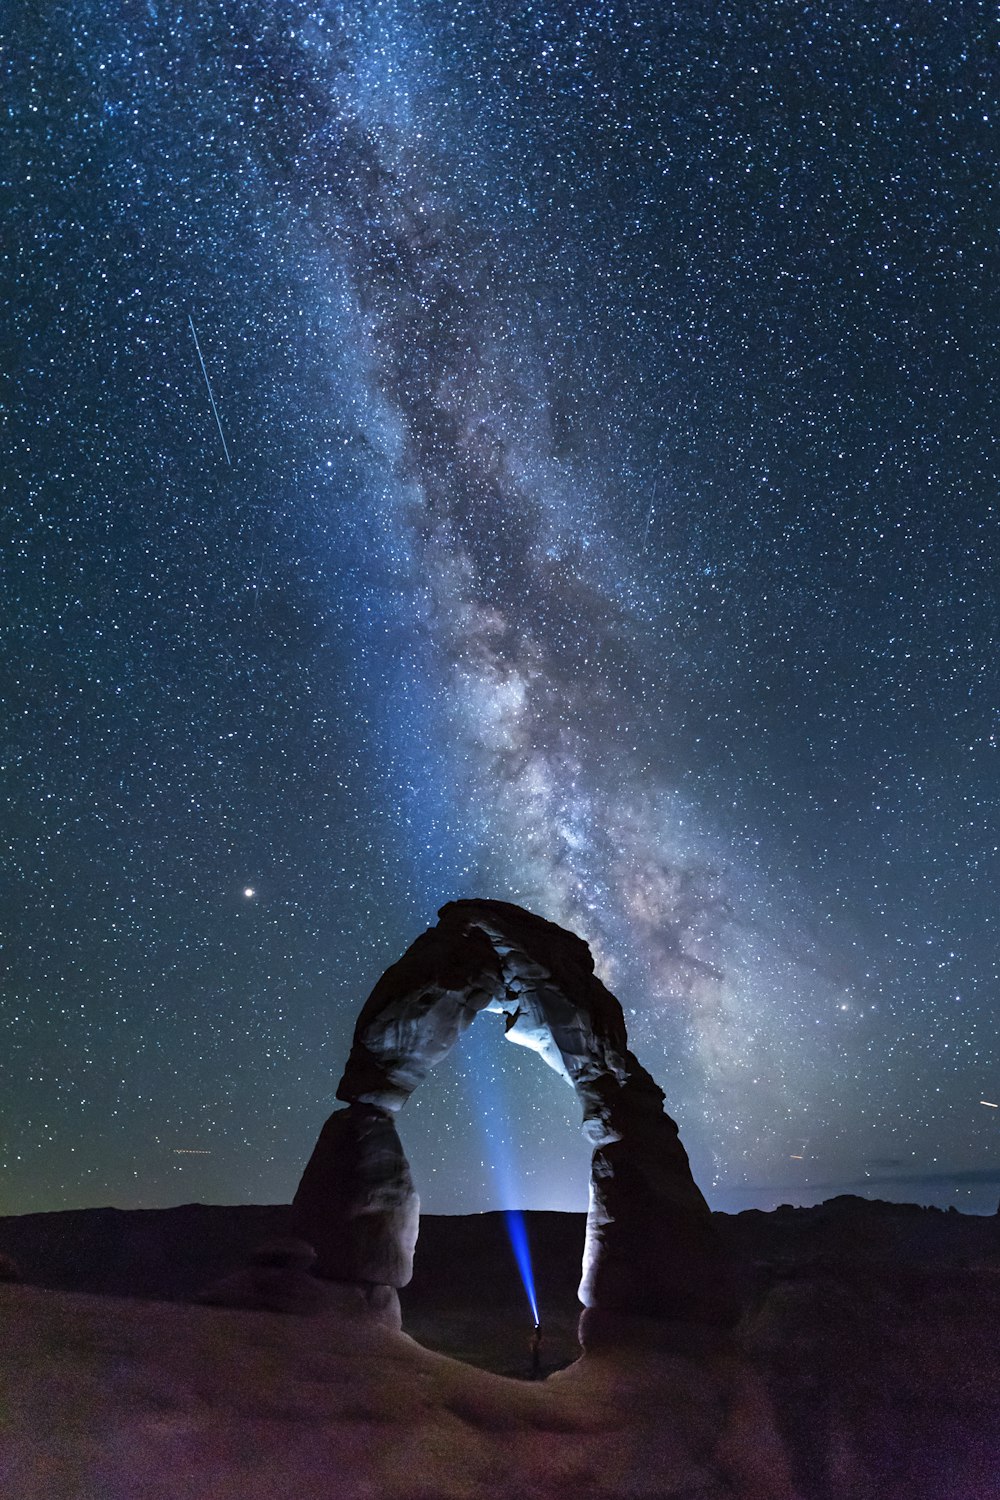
[0,1199,1000,1500]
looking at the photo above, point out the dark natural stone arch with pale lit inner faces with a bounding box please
[292,900,732,1323]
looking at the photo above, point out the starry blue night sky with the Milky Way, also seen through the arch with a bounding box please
[0,0,1000,1214]
